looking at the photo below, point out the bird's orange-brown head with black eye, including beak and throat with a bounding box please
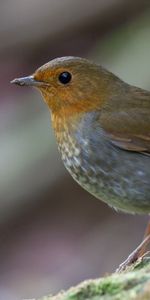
[12,57,122,116]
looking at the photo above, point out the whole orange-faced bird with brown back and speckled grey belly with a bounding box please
[11,56,150,267]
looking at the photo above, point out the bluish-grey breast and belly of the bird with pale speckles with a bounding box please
[54,114,150,213]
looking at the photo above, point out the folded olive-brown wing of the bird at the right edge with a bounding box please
[100,89,150,153]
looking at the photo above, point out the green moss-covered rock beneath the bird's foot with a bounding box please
[36,257,150,300]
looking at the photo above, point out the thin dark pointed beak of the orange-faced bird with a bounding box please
[10,75,48,87]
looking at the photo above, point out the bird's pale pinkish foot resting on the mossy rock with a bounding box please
[116,234,150,273]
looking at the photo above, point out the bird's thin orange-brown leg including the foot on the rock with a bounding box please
[116,221,150,273]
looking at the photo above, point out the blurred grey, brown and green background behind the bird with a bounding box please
[0,0,150,300]
